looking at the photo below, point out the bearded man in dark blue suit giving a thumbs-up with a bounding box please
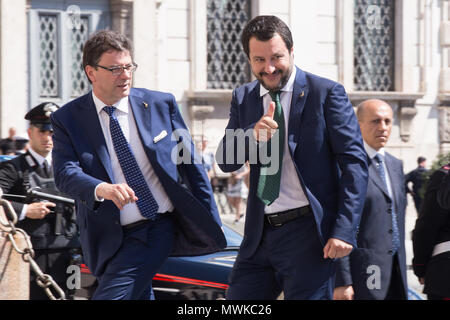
[216,16,367,299]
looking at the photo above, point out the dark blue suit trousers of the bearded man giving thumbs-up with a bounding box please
[227,214,335,300]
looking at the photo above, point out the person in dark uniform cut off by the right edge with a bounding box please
[412,163,450,300]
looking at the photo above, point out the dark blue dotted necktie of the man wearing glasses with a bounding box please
[103,106,158,220]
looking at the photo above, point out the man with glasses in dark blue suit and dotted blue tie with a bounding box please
[51,31,226,299]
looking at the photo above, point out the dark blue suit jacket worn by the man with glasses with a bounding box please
[51,88,226,276]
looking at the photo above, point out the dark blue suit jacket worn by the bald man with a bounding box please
[336,153,407,300]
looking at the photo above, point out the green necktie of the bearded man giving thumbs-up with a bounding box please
[256,91,285,206]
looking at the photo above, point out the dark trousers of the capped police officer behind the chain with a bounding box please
[30,249,72,300]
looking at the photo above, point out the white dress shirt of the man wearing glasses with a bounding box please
[92,92,173,225]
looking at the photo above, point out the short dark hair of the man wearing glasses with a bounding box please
[83,30,133,81]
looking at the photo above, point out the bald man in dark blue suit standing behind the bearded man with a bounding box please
[333,99,407,300]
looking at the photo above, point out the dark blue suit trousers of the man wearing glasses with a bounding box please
[92,214,175,300]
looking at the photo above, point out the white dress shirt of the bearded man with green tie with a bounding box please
[259,67,309,214]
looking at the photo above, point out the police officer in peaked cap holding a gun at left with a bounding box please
[0,102,79,300]
